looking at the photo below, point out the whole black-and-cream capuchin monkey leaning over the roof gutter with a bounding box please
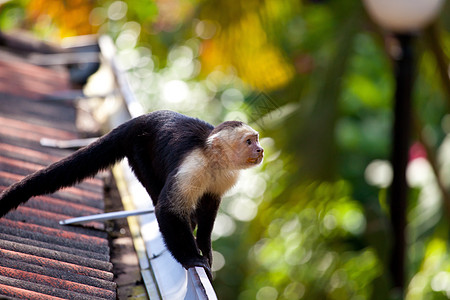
[0,111,264,278]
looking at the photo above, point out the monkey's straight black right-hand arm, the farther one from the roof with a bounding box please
[196,194,220,266]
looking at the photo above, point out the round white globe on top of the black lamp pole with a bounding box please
[363,0,444,33]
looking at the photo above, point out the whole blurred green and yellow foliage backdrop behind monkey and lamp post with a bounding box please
[0,0,450,300]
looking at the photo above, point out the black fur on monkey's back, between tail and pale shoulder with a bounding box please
[127,110,214,204]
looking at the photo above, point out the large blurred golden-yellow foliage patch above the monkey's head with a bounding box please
[202,12,294,91]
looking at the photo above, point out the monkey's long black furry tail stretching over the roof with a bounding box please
[0,122,131,217]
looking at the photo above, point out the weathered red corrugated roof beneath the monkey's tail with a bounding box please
[0,44,116,299]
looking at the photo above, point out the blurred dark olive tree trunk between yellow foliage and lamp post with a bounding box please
[294,9,361,180]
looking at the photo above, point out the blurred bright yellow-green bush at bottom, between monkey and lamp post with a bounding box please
[240,181,381,299]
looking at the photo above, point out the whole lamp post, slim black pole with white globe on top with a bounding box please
[364,0,443,295]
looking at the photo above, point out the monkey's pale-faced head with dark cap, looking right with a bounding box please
[208,121,264,169]
